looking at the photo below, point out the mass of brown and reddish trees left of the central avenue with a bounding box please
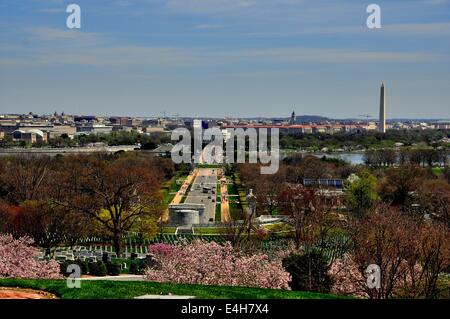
[0,152,174,255]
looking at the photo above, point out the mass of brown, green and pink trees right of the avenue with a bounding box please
[234,156,450,298]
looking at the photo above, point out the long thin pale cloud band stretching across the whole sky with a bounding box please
[0,46,442,67]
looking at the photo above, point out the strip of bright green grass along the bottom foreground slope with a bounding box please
[0,279,342,299]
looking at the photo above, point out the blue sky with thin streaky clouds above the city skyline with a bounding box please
[0,0,450,118]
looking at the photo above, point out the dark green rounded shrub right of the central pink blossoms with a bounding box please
[283,251,332,292]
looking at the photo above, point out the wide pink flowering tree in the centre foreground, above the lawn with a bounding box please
[145,240,291,289]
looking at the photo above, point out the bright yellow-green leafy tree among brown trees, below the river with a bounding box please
[345,172,379,217]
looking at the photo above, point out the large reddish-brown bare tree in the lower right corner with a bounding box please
[350,205,450,299]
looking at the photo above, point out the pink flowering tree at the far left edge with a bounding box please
[0,235,61,279]
